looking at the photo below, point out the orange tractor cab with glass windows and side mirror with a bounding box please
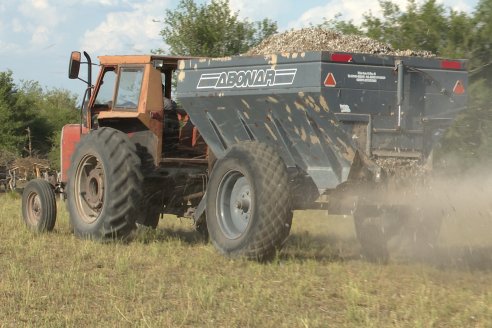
[69,52,206,174]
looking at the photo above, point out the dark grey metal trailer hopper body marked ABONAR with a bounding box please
[177,52,467,194]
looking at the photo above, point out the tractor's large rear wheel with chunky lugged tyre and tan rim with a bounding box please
[67,128,143,240]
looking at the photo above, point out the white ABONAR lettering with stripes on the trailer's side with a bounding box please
[197,68,297,89]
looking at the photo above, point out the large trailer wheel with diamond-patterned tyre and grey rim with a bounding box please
[206,142,292,261]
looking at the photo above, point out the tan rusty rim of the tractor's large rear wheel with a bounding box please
[74,154,104,224]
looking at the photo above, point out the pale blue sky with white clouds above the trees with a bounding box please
[0,0,478,100]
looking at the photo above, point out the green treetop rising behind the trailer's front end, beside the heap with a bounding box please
[154,0,277,57]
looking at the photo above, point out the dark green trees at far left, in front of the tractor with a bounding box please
[0,71,79,167]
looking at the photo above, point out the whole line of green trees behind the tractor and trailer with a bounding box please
[0,0,492,167]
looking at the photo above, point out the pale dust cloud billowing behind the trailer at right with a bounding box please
[386,160,492,269]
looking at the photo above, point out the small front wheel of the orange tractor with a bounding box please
[22,179,56,232]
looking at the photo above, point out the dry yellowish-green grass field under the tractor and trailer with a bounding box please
[0,194,492,327]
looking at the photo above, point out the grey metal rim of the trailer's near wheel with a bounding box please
[217,171,253,239]
